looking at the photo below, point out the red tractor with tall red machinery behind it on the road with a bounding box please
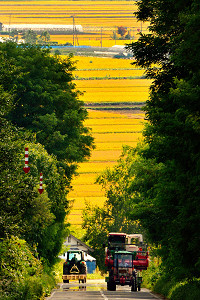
[105,233,149,291]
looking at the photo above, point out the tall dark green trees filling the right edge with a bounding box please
[126,0,200,278]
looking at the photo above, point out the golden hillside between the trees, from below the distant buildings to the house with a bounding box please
[69,57,150,226]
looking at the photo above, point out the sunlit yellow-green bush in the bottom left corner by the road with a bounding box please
[0,236,55,300]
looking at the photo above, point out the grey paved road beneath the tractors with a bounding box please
[46,280,164,300]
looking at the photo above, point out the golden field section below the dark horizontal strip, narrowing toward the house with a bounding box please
[69,110,144,226]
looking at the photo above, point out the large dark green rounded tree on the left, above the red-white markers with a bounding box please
[0,43,93,180]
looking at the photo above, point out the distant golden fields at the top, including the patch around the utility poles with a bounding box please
[0,0,147,47]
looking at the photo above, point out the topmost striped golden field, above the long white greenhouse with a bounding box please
[0,0,147,30]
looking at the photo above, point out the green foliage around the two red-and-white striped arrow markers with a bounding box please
[0,119,68,263]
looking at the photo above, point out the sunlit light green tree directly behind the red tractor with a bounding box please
[83,146,143,271]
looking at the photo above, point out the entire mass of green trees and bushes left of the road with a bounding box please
[0,42,93,299]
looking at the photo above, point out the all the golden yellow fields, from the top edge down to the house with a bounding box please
[0,0,151,226]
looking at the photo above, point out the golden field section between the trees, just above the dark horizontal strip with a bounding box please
[73,57,151,103]
